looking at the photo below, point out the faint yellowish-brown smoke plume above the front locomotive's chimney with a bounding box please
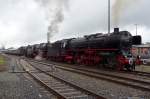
[112,0,138,27]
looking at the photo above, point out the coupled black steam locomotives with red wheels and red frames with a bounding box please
[5,28,141,70]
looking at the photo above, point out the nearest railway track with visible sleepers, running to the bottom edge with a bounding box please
[18,59,105,99]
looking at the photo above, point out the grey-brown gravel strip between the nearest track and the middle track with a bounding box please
[30,62,150,99]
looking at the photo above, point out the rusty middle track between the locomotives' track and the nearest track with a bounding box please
[25,60,150,91]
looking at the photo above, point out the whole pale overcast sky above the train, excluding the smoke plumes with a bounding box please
[0,0,150,47]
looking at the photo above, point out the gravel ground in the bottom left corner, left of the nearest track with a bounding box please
[0,56,55,99]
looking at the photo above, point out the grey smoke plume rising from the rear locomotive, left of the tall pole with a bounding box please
[37,0,69,42]
